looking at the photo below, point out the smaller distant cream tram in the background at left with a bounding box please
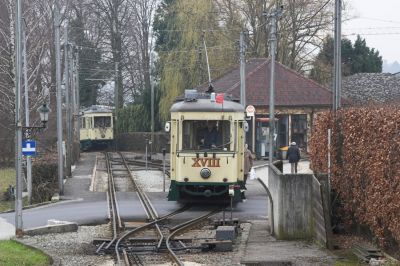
[79,105,114,151]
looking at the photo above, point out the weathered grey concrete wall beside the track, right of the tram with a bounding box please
[268,163,315,239]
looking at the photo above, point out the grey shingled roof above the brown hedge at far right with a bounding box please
[342,73,400,104]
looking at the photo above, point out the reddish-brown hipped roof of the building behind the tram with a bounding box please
[197,58,332,107]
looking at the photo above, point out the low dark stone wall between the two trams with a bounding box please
[116,132,170,153]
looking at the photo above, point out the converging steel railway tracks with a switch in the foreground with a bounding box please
[97,153,221,265]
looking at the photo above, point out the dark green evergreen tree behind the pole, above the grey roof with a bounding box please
[310,36,383,86]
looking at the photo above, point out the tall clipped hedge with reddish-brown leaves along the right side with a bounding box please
[310,106,400,246]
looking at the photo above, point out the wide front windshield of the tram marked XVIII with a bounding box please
[182,120,233,151]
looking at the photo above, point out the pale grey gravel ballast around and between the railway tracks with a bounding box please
[20,153,250,266]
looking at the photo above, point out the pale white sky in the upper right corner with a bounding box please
[342,0,400,63]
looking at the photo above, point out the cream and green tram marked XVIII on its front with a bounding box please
[166,91,247,202]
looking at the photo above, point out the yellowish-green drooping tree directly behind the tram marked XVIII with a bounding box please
[154,0,239,120]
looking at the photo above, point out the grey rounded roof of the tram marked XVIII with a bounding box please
[170,99,244,112]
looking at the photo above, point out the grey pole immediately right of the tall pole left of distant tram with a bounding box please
[64,23,71,177]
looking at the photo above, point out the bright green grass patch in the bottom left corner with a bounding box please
[0,240,51,266]
